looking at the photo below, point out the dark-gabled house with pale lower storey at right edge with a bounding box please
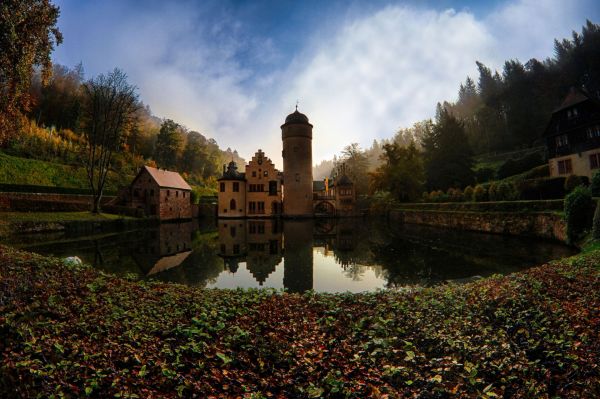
[544,88,600,177]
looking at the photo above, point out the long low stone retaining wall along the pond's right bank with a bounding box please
[389,210,567,242]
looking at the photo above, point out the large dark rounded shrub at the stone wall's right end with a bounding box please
[565,186,593,243]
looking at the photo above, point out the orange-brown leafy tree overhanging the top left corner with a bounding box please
[0,0,62,145]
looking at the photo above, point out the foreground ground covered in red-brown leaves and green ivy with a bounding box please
[0,247,600,398]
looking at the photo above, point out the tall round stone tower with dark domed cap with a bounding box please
[281,107,313,217]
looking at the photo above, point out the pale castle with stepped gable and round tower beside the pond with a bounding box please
[217,107,356,218]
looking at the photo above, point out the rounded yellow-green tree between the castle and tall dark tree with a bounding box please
[371,142,425,202]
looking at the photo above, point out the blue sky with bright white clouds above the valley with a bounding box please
[53,0,600,169]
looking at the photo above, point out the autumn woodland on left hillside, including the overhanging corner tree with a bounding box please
[0,1,244,198]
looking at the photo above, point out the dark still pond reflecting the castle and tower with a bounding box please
[5,219,573,292]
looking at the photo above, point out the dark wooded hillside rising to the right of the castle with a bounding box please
[326,20,600,201]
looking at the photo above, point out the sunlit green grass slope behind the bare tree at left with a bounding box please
[0,152,133,191]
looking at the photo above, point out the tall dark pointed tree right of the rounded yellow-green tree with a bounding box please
[422,104,474,191]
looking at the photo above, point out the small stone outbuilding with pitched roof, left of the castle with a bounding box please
[121,166,192,220]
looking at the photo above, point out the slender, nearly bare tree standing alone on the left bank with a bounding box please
[83,68,138,213]
